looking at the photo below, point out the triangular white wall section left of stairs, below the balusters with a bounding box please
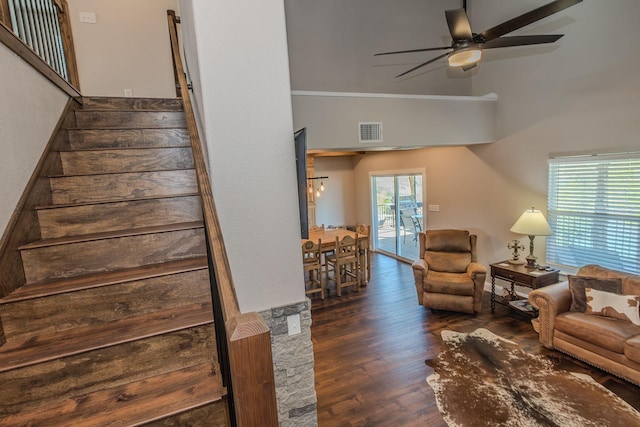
[0,44,68,236]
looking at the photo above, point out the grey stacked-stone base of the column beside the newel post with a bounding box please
[260,298,318,427]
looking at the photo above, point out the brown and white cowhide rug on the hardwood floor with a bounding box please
[427,329,640,427]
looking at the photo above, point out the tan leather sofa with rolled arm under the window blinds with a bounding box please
[529,265,640,385]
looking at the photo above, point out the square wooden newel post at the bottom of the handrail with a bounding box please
[226,312,278,427]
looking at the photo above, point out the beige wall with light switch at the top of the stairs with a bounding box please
[69,0,178,98]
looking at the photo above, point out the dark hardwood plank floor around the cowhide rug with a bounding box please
[311,254,640,427]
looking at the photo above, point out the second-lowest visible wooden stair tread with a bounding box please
[0,303,213,372]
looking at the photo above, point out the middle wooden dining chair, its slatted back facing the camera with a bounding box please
[325,234,360,296]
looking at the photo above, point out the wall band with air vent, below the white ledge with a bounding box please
[292,92,496,150]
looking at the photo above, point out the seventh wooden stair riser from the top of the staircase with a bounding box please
[21,228,206,283]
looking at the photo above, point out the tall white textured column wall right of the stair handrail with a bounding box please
[178,0,304,312]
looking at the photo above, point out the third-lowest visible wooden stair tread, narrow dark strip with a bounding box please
[0,257,208,304]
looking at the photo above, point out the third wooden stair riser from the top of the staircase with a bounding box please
[68,129,189,150]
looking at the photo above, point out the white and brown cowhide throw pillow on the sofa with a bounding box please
[585,288,640,326]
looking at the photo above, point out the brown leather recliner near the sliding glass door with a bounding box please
[412,230,487,314]
